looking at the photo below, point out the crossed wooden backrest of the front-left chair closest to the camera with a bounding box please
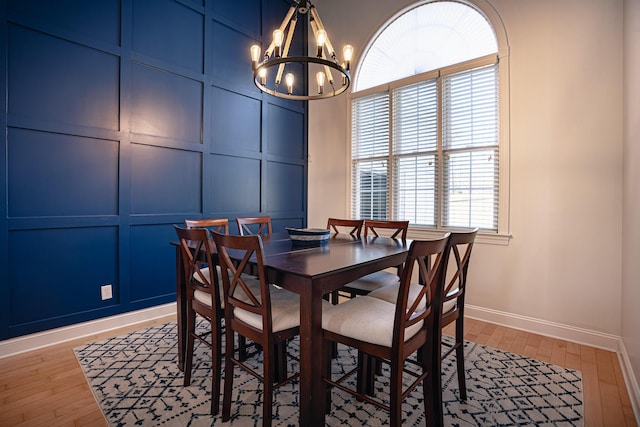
[211,232,273,333]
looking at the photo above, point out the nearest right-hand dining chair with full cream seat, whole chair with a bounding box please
[322,236,449,427]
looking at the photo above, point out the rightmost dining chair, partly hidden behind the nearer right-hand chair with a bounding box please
[369,228,478,400]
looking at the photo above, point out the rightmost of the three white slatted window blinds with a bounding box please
[442,65,499,230]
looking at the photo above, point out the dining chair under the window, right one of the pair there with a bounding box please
[340,219,409,298]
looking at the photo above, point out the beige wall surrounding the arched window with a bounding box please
[309,0,624,342]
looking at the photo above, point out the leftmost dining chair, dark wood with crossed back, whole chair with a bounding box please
[174,225,223,415]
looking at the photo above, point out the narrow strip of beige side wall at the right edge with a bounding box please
[622,0,640,412]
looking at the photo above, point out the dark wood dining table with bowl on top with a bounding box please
[176,233,411,426]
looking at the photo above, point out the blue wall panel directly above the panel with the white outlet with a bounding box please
[7,128,118,218]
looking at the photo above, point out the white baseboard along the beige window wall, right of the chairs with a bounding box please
[464,304,620,353]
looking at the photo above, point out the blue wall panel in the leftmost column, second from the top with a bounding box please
[8,25,120,130]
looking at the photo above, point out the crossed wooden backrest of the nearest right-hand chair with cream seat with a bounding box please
[393,234,449,354]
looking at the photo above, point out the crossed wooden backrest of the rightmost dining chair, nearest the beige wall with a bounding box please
[442,228,478,315]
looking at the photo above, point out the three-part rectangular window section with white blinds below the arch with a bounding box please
[352,64,499,231]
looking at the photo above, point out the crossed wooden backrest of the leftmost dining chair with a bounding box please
[174,225,221,307]
